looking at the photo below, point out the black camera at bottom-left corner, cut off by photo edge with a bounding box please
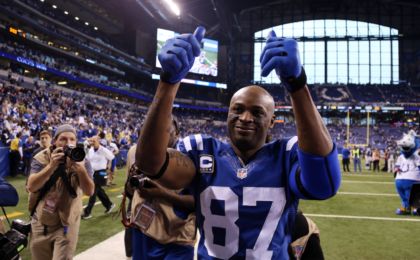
[0,219,31,260]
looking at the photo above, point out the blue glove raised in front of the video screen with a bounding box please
[158,26,206,84]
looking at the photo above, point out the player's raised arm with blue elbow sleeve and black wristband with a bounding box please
[260,31,341,199]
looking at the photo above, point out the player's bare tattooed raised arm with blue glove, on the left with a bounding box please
[136,27,204,189]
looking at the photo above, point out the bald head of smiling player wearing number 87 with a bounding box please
[227,86,274,151]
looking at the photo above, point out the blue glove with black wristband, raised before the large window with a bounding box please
[260,31,306,92]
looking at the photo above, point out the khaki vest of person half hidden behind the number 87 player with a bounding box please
[127,146,196,246]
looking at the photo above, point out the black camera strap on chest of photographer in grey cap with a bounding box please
[31,164,77,217]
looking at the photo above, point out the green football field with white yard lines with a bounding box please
[6,170,420,260]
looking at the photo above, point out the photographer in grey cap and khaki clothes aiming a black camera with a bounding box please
[27,125,94,260]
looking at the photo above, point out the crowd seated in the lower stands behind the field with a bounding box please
[0,74,416,177]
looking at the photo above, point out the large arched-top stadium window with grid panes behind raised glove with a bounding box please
[254,19,399,84]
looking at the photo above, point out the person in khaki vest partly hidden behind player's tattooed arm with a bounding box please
[126,117,196,260]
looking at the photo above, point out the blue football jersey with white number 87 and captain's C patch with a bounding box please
[178,135,298,259]
